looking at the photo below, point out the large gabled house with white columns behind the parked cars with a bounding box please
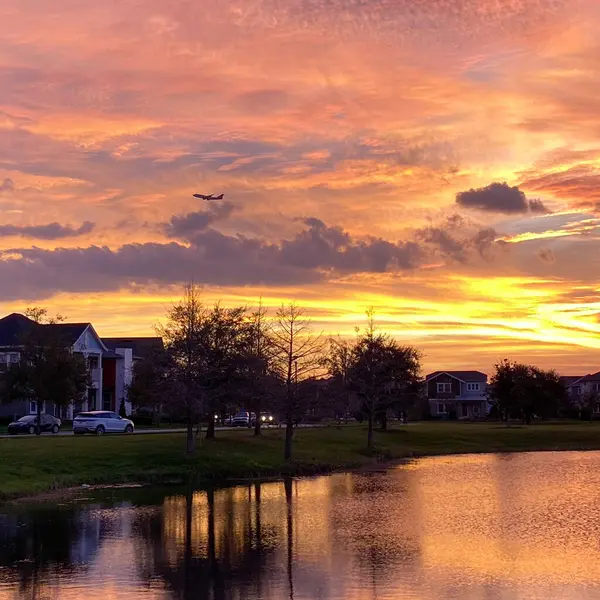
[0,313,162,419]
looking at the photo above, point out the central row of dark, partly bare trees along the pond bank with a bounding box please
[129,285,421,459]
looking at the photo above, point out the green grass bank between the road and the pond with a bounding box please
[0,423,600,500]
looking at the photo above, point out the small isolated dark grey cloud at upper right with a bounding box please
[456,183,548,214]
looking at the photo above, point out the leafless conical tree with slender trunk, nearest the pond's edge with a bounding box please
[273,303,323,460]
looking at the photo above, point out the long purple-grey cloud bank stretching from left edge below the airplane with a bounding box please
[0,203,497,300]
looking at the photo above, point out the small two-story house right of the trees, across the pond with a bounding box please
[425,371,489,419]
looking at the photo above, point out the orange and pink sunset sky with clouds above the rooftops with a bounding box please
[0,0,600,374]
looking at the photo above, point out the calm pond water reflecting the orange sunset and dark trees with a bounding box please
[0,452,600,600]
